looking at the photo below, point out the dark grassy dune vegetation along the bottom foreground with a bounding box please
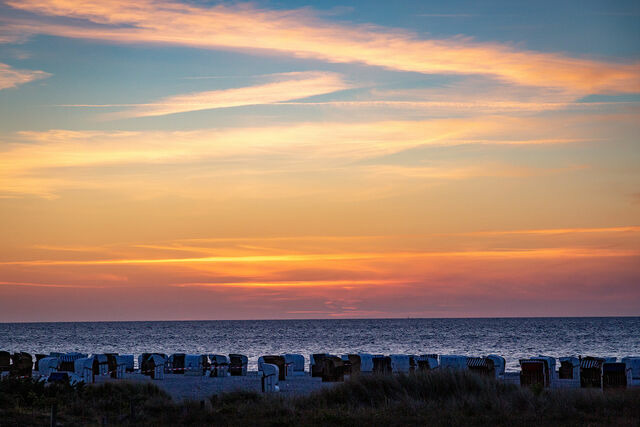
[0,371,640,426]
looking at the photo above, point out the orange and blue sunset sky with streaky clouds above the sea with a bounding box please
[0,0,640,322]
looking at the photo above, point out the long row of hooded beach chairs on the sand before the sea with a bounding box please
[0,351,640,389]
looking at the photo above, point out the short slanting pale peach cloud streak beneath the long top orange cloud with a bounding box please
[102,71,350,118]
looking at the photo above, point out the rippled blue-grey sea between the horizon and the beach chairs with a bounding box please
[0,317,640,370]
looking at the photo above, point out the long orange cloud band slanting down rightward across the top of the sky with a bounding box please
[8,0,640,95]
